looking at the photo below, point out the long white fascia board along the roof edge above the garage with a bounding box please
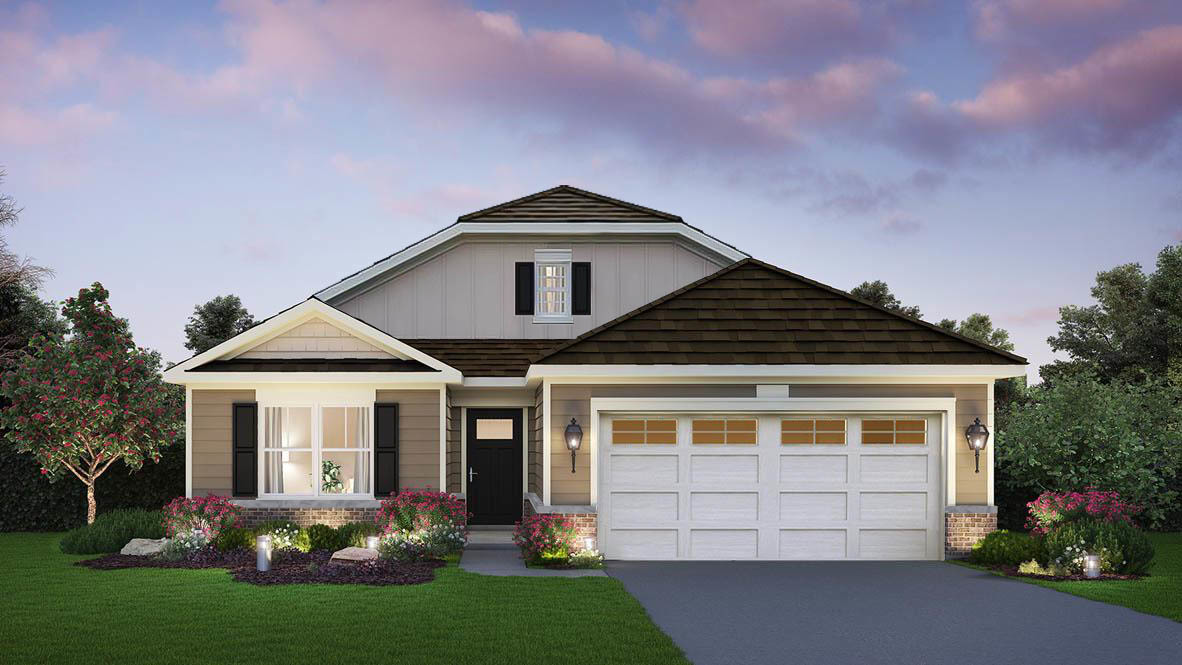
[526,365,1026,383]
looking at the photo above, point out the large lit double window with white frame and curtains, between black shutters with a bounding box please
[262,406,372,496]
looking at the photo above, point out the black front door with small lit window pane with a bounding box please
[463,409,522,524]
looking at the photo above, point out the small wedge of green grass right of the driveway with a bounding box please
[959,533,1182,622]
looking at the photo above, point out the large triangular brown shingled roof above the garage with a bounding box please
[534,259,1026,365]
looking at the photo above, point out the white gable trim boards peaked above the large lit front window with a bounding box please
[164,298,462,383]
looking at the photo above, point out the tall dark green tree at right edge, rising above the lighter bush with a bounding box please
[1040,245,1182,385]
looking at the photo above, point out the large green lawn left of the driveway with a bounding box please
[0,534,687,665]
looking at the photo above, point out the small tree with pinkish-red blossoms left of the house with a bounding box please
[0,282,184,523]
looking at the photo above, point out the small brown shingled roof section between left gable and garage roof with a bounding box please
[398,338,566,377]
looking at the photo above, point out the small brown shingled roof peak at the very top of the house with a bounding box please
[457,184,682,222]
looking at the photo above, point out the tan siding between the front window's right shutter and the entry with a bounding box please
[377,390,440,489]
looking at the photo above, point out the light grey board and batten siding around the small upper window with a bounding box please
[331,240,723,339]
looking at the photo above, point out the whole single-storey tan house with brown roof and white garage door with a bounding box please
[165,187,1026,560]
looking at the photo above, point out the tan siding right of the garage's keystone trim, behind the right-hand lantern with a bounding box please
[790,384,993,506]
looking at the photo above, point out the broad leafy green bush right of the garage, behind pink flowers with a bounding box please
[995,374,1182,527]
